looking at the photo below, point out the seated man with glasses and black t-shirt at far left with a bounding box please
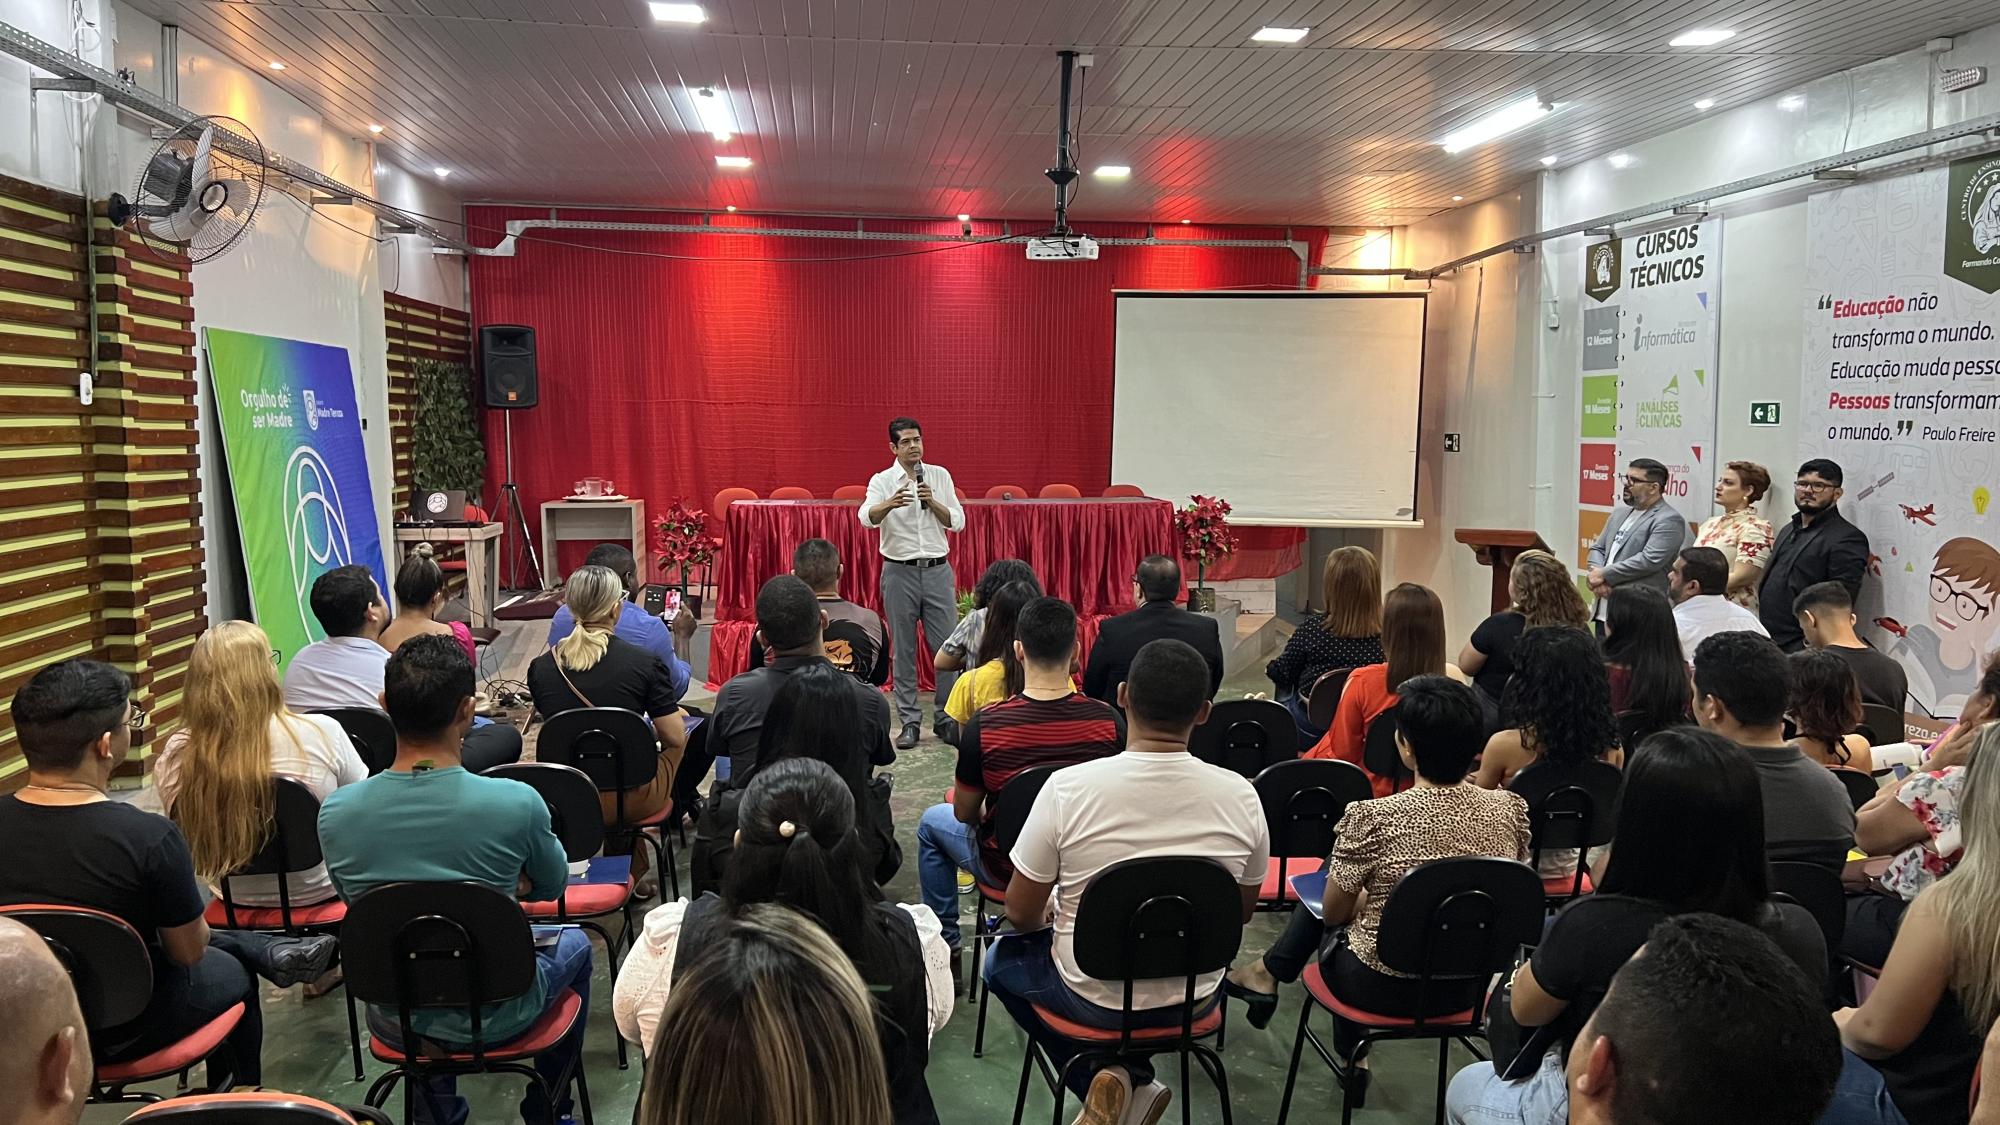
[0,657,338,1089]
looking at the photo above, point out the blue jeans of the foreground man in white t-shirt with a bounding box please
[986,929,1222,1097]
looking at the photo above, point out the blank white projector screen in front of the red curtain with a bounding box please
[1112,290,1424,526]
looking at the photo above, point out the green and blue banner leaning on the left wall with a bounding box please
[204,328,390,661]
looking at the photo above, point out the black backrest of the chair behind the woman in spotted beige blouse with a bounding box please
[1376,855,1542,979]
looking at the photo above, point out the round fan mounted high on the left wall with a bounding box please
[106,116,264,262]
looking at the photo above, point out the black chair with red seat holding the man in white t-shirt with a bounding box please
[1014,857,1244,1125]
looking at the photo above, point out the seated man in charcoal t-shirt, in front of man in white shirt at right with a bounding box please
[1688,633,1854,871]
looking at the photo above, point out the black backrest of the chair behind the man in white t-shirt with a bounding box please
[1072,855,1244,1001]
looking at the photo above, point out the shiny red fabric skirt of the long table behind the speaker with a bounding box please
[708,496,1174,691]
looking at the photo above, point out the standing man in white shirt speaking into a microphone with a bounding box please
[860,418,966,751]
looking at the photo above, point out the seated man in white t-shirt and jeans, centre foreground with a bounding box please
[986,639,1270,1123]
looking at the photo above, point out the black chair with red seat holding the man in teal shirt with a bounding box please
[340,883,594,1125]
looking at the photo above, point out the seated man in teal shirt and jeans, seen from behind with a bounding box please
[320,636,584,1125]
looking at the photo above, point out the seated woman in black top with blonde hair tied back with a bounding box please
[528,567,688,899]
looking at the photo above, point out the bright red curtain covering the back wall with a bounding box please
[466,206,1324,573]
